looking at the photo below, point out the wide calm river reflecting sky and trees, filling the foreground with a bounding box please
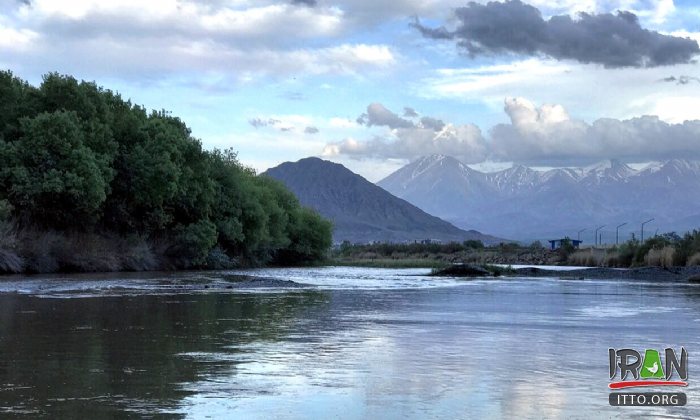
[0,267,700,419]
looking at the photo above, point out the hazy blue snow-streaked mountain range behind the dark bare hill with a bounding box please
[378,155,700,243]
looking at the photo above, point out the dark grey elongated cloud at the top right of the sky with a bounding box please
[413,0,700,68]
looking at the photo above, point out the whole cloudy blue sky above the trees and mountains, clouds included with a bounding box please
[0,0,700,181]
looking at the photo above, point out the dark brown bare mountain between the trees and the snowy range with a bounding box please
[262,158,501,243]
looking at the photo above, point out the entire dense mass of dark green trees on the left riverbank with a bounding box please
[0,71,332,268]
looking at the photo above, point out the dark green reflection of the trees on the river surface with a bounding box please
[0,291,328,417]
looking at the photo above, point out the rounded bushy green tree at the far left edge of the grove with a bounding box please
[0,111,113,229]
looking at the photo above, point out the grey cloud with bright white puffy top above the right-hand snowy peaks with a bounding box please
[489,98,700,166]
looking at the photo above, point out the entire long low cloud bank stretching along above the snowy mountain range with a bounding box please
[322,98,700,166]
